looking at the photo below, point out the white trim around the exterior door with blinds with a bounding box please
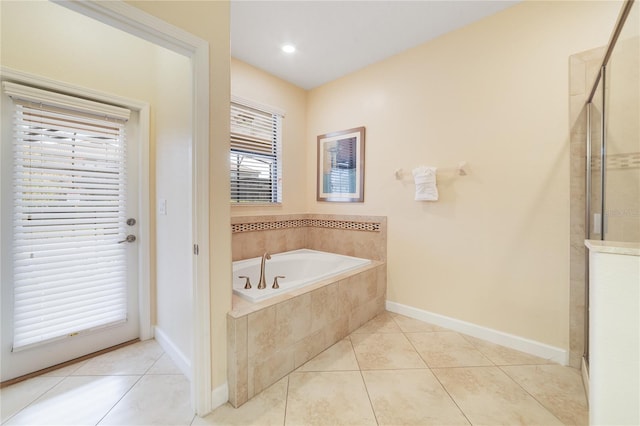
[0,66,153,340]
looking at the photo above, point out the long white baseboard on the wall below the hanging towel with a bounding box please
[386,300,569,365]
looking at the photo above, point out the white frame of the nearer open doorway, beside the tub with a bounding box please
[51,0,212,416]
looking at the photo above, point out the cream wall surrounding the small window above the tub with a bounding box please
[231,58,309,216]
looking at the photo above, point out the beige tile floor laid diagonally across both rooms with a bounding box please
[0,312,588,426]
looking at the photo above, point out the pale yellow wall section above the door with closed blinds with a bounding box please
[1,1,154,102]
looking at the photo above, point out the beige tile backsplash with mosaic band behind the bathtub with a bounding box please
[231,214,387,261]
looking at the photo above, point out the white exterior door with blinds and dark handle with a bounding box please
[0,81,140,381]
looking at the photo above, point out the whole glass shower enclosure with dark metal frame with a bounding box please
[585,1,640,361]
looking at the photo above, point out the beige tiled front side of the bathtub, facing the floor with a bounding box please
[227,261,386,407]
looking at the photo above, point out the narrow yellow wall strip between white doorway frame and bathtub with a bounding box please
[128,1,231,388]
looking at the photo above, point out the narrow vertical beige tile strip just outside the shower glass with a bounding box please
[569,47,605,368]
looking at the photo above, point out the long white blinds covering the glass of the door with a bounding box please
[3,82,129,351]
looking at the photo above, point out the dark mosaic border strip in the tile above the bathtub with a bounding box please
[231,219,381,234]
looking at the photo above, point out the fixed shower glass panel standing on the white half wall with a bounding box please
[594,2,640,242]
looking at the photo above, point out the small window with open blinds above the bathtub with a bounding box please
[229,98,283,204]
